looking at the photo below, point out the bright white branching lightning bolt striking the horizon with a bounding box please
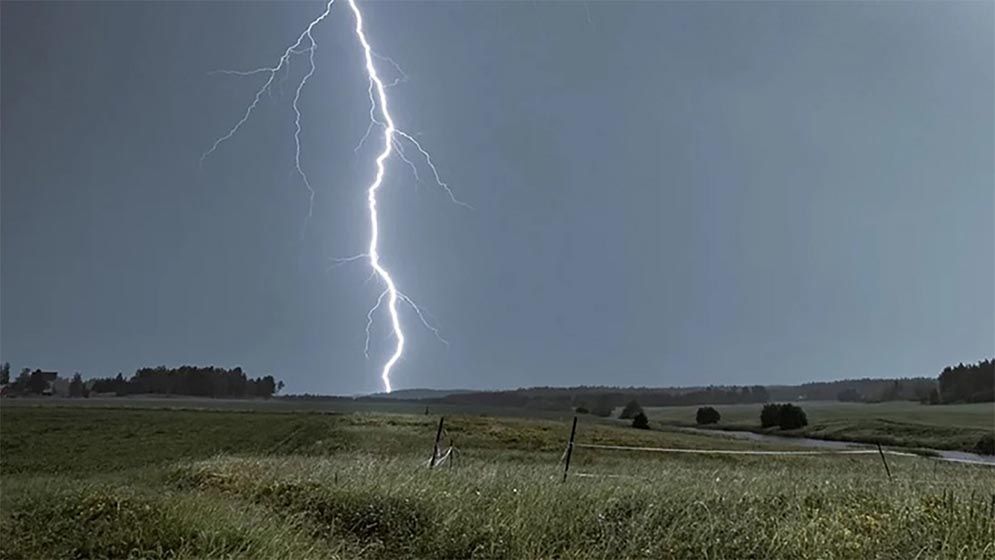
[208,0,471,393]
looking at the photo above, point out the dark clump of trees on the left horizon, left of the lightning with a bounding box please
[87,366,283,398]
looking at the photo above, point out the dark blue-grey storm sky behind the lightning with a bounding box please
[0,2,995,393]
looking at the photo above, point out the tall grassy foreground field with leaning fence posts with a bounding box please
[0,403,995,559]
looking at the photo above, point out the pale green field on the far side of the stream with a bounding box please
[646,401,995,451]
